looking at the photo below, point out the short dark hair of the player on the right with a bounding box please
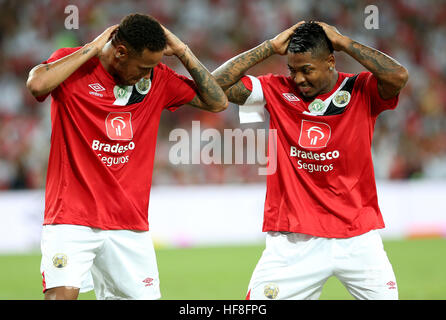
[287,21,333,57]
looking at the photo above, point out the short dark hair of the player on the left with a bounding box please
[112,13,167,54]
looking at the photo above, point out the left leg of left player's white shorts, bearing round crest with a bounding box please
[40,225,100,292]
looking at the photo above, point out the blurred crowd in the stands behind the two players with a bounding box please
[0,0,446,190]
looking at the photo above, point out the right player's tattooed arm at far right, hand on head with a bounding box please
[319,22,409,99]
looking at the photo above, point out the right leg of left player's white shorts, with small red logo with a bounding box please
[92,230,161,300]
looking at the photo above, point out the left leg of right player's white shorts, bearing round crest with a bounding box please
[247,232,332,300]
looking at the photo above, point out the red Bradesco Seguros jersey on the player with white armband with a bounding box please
[240,72,398,238]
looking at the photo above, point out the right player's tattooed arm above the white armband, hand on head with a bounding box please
[212,21,304,105]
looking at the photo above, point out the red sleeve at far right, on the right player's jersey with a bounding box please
[360,72,399,116]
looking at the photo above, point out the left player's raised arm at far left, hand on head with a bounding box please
[26,25,118,97]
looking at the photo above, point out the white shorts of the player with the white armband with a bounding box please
[247,230,398,300]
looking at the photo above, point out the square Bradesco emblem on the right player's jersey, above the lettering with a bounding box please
[299,120,331,149]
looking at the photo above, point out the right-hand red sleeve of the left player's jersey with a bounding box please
[165,67,197,111]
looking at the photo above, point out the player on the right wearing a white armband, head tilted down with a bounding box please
[213,21,408,299]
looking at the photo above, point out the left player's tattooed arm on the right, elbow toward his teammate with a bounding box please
[163,26,228,112]
